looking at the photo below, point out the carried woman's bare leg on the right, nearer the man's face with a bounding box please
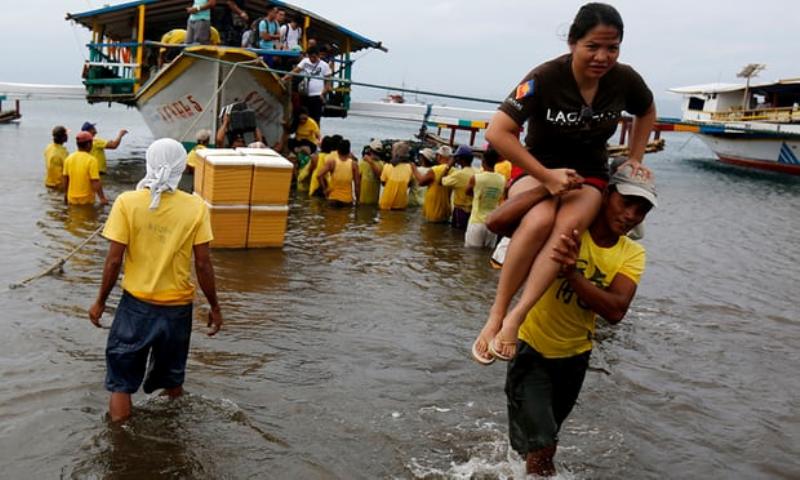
[494,185,603,357]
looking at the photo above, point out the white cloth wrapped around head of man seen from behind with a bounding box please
[136,138,186,210]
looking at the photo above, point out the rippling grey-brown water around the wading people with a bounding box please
[0,102,800,479]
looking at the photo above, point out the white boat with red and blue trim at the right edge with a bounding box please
[659,70,800,175]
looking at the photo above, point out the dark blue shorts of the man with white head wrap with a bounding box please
[106,292,192,393]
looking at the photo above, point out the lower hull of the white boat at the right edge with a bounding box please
[699,134,800,175]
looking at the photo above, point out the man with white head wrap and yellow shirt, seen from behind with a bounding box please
[89,138,222,421]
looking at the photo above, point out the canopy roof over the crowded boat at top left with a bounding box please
[67,0,387,52]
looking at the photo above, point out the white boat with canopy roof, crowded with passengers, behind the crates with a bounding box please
[67,0,386,147]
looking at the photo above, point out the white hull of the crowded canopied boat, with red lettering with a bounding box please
[136,47,290,146]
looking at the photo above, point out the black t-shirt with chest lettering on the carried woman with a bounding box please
[499,54,653,179]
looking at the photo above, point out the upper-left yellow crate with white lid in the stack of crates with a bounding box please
[201,155,253,205]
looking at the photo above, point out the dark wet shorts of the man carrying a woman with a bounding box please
[506,341,591,456]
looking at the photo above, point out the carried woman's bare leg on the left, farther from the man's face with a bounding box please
[475,177,557,359]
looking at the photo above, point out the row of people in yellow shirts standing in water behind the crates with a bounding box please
[291,128,511,247]
